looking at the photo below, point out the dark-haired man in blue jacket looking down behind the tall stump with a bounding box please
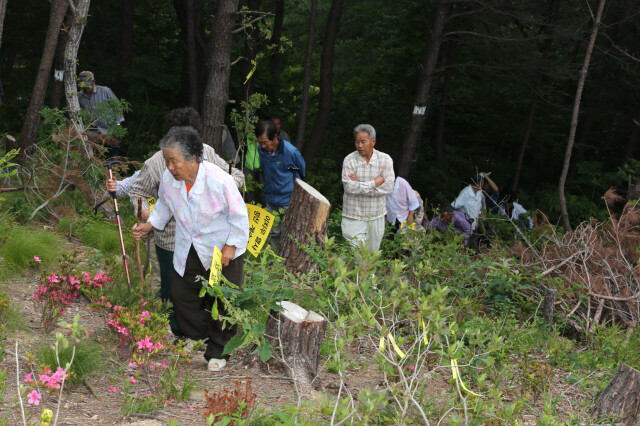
[255,120,305,248]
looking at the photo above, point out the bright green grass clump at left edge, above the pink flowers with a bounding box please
[0,226,64,272]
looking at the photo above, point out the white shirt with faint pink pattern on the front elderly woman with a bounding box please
[149,161,249,276]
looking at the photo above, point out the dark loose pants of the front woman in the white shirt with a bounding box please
[171,246,244,361]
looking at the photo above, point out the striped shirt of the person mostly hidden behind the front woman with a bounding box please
[129,145,244,251]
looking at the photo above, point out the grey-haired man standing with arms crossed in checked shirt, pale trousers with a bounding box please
[342,124,395,253]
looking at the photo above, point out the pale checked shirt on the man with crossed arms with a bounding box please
[342,149,395,220]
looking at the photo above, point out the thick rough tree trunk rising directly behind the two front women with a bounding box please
[202,0,238,151]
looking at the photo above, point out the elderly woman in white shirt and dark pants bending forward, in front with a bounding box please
[133,127,249,371]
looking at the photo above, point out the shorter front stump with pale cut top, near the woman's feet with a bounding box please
[265,302,327,392]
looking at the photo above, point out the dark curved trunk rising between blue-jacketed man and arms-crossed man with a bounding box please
[303,0,344,167]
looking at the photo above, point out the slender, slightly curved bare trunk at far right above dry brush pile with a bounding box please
[558,0,606,232]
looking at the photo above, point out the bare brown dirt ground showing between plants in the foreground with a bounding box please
[0,238,599,425]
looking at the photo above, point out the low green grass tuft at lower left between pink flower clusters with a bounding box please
[38,340,103,385]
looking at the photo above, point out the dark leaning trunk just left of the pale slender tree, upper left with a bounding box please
[19,0,69,161]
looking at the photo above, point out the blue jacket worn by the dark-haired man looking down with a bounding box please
[258,138,305,207]
